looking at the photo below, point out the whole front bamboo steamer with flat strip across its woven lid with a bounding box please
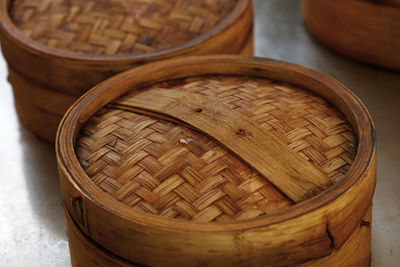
[56,56,376,266]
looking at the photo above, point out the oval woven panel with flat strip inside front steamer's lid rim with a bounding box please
[76,75,357,222]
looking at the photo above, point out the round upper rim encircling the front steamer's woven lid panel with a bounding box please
[56,55,376,232]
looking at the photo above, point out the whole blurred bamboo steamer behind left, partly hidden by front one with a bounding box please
[0,0,253,143]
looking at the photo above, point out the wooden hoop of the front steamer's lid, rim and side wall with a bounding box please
[56,56,376,266]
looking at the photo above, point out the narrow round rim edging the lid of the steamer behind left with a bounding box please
[0,0,252,64]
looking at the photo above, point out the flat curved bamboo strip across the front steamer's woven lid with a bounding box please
[119,89,331,202]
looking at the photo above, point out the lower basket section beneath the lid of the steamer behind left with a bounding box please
[8,34,254,144]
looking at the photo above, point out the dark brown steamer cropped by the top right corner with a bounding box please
[301,0,400,70]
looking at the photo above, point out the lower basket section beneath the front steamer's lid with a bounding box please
[64,206,372,267]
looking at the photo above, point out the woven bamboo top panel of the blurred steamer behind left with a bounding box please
[8,0,250,57]
